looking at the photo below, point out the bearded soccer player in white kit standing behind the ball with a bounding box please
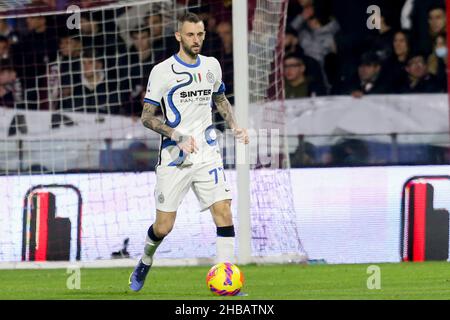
[130,13,249,291]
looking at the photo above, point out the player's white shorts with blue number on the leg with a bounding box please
[155,162,232,212]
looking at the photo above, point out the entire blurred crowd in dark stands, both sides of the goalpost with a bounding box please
[0,0,448,116]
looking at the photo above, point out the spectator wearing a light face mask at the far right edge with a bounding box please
[428,33,448,91]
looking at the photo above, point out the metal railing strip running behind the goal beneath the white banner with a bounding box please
[0,132,450,175]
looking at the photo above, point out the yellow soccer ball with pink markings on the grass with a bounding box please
[206,262,244,296]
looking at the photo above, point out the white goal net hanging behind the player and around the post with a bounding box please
[0,0,306,265]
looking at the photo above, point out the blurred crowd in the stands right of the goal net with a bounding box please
[284,0,448,99]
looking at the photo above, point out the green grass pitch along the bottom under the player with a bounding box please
[0,262,450,300]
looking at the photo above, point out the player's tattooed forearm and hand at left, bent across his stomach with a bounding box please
[141,103,198,153]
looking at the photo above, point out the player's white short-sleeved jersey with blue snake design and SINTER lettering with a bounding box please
[144,54,225,166]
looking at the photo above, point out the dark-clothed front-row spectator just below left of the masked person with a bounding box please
[399,53,442,93]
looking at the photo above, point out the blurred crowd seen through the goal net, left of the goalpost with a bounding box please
[0,0,233,116]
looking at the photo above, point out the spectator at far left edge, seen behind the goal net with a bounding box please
[0,60,23,108]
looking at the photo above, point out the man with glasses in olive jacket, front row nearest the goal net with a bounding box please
[284,54,325,99]
